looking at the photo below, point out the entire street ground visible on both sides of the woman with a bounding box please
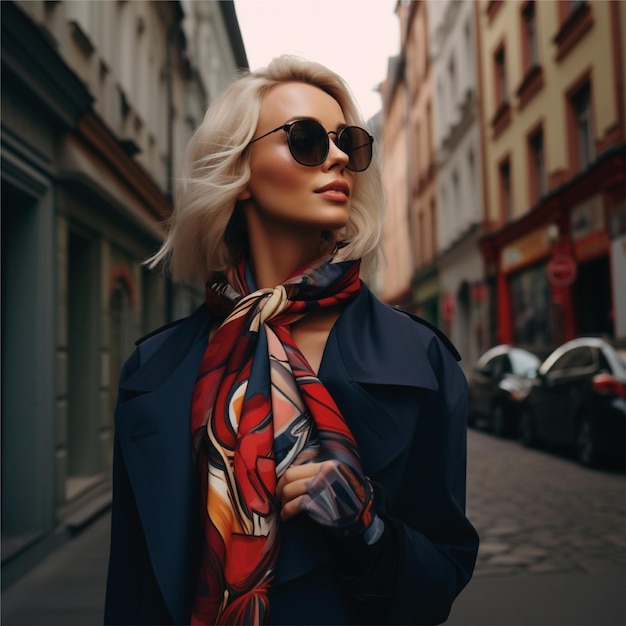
[2,430,626,626]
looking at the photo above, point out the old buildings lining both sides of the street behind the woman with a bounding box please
[0,0,626,586]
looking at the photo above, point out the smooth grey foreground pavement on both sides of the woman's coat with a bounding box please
[1,514,626,626]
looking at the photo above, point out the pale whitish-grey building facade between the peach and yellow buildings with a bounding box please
[428,0,488,364]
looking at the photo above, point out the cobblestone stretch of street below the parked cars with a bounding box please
[467,430,626,577]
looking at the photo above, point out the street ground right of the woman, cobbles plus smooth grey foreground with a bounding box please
[447,429,626,626]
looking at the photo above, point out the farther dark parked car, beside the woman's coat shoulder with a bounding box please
[468,344,541,437]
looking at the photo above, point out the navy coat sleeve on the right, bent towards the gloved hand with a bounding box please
[336,330,478,624]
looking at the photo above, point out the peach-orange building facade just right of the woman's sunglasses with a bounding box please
[379,1,440,324]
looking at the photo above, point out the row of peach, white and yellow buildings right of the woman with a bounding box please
[383,0,626,365]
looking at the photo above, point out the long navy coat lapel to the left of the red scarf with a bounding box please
[116,304,208,624]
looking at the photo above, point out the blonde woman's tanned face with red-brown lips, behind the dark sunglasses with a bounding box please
[240,82,354,238]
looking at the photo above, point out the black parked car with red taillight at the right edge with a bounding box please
[520,337,626,466]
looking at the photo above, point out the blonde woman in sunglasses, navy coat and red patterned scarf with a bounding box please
[105,57,478,624]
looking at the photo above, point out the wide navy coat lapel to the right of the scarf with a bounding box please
[320,287,439,480]
